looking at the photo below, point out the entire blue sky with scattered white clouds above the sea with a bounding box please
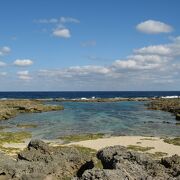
[0,0,180,91]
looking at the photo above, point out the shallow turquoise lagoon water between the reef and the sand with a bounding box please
[1,101,180,139]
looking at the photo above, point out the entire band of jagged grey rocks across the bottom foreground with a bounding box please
[0,140,180,180]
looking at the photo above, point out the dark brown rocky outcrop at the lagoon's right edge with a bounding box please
[148,98,180,121]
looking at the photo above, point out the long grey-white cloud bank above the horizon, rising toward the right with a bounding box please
[3,34,180,90]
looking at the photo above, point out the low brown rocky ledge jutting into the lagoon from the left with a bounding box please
[0,99,64,120]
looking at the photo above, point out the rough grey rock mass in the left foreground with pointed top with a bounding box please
[0,140,91,179]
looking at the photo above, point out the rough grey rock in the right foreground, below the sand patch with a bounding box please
[79,146,180,180]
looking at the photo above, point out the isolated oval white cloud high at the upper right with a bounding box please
[136,20,173,34]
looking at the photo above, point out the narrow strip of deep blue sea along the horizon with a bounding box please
[0,91,180,99]
